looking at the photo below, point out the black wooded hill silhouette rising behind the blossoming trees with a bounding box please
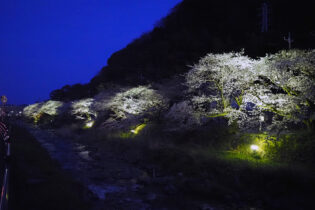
[51,0,315,100]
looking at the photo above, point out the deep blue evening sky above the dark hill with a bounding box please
[0,0,181,104]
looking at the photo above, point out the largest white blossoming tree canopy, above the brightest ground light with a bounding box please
[186,50,315,132]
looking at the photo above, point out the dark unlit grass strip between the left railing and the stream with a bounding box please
[9,124,90,210]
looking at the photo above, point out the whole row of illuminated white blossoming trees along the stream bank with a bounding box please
[24,50,315,139]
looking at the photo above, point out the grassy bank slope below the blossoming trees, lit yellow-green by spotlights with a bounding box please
[51,123,315,209]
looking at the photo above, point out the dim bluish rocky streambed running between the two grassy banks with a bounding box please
[15,123,223,210]
